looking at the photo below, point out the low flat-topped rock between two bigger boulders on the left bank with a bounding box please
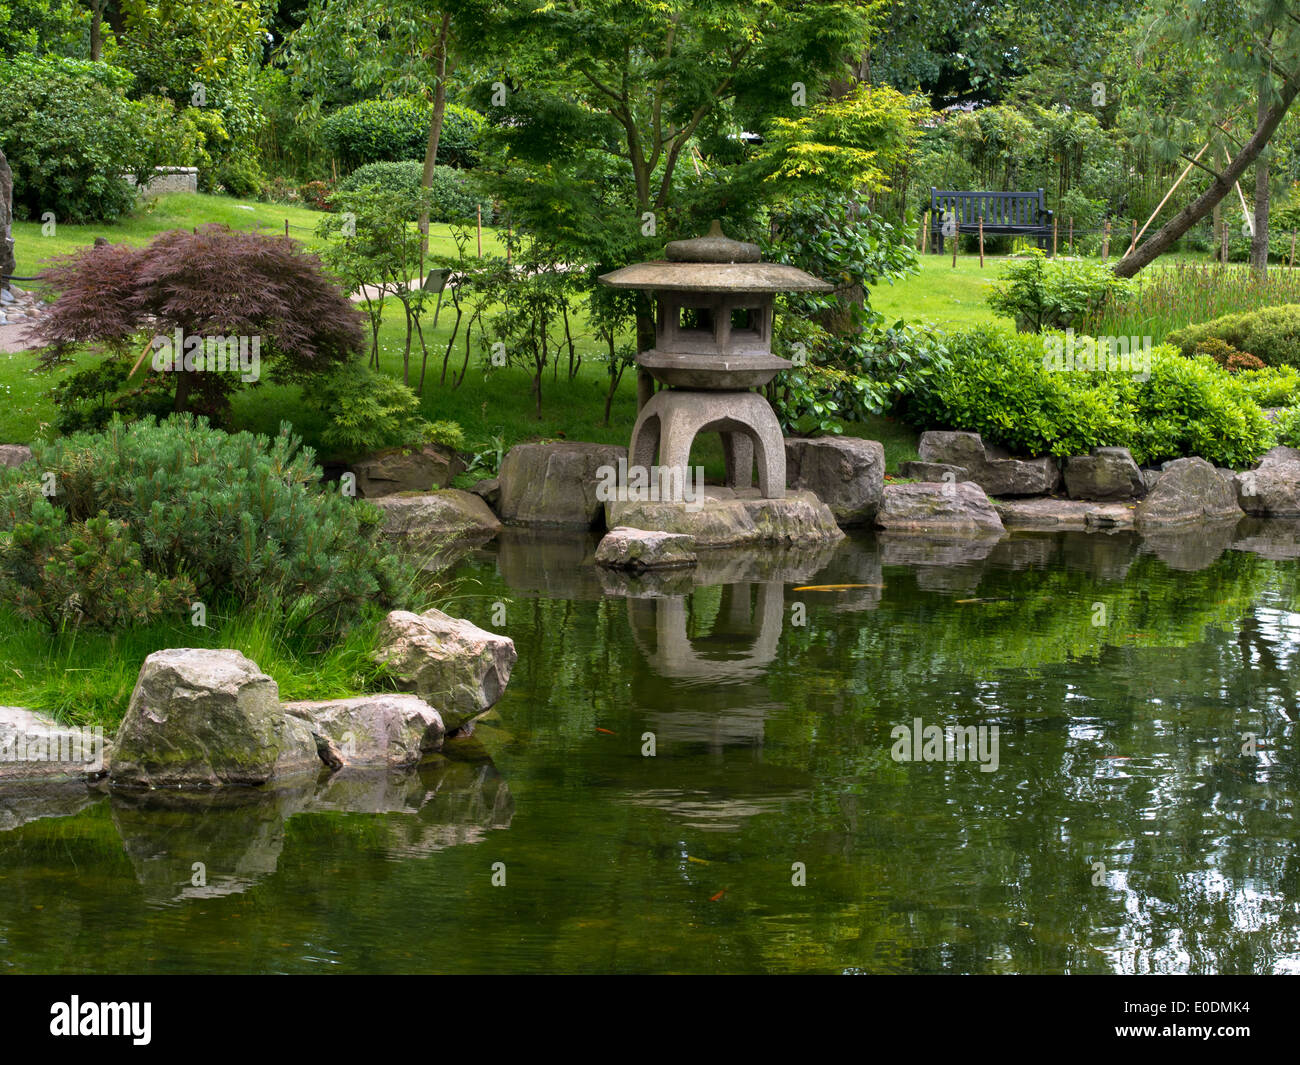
[282,694,446,769]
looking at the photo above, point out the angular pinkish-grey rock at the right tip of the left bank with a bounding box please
[374,610,517,732]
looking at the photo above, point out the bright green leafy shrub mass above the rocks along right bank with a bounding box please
[907,326,1273,468]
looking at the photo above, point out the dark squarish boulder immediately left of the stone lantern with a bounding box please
[498,441,627,528]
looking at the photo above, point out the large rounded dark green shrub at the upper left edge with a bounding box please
[0,56,147,222]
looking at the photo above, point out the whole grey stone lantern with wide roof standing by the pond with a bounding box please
[599,221,832,499]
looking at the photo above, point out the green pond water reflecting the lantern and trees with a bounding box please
[0,523,1300,973]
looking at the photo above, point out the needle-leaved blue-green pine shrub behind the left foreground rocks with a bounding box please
[0,415,399,632]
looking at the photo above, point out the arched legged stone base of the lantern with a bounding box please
[628,389,785,499]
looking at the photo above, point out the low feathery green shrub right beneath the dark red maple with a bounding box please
[303,364,464,458]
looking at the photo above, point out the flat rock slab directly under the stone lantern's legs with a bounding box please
[606,486,844,549]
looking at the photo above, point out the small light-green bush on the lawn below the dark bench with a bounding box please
[987,248,1132,333]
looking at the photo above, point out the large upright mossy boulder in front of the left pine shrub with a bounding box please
[109,648,321,788]
